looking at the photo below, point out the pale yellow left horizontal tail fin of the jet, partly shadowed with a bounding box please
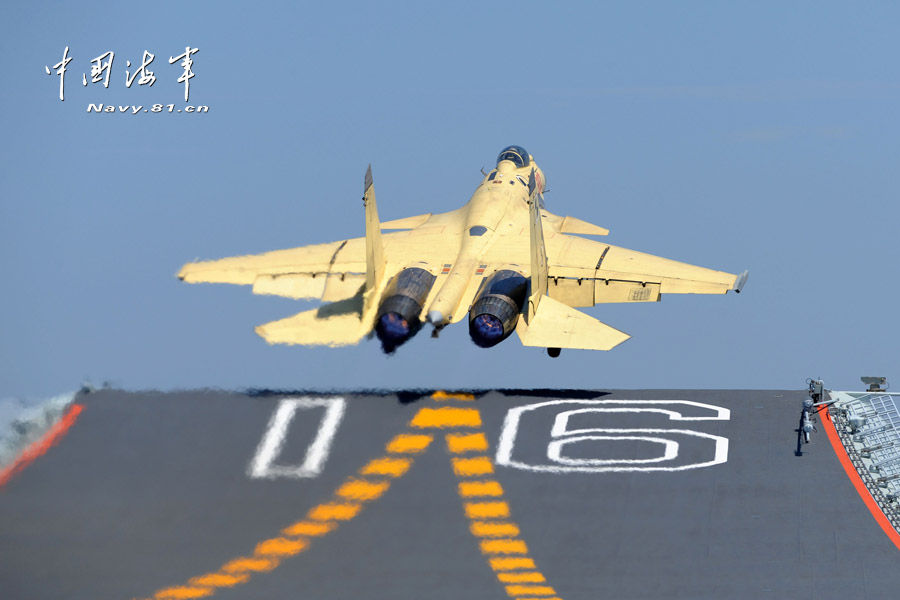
[256,295,370,346]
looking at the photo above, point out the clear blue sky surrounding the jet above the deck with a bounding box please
[0,2,900,397]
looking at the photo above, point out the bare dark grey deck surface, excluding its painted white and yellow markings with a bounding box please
[0,390,900,600]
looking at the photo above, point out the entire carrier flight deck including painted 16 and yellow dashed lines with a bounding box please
[0,390,900,600]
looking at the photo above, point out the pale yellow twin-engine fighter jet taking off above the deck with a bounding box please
[178,146,747,356]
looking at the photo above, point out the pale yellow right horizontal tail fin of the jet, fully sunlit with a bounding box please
[516,296,631,350]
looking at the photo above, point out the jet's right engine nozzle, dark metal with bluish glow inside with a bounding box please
[469,269,528,348]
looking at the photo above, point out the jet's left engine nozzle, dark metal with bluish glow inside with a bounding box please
[375,267,435,354]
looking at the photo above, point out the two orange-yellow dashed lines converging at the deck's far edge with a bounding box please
[142,392,559,600]
